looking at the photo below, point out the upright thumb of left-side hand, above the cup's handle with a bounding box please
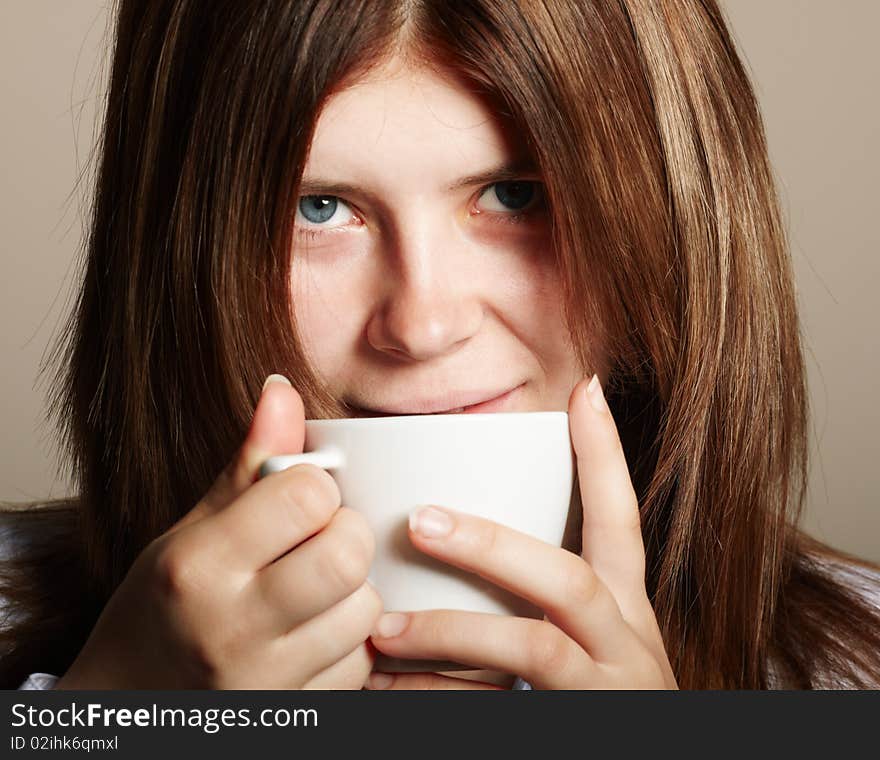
[172,375,305,530]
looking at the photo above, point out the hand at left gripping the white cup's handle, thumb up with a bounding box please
[56,376,382,689]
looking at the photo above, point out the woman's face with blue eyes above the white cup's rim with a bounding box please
[292,61,582,415]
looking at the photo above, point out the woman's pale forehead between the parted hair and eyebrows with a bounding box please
[306,60,525,178]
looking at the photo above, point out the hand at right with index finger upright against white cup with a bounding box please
[369,378,676,689]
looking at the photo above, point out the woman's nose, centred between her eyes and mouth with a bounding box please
[367,223,483,361]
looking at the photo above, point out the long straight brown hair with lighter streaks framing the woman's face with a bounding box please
[0,0,880,688]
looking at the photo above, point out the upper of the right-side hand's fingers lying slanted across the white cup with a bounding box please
[410,507,631,664]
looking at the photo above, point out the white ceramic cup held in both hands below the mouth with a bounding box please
[260,412,574,671]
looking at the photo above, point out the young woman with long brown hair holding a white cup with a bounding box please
[0,0,880,689]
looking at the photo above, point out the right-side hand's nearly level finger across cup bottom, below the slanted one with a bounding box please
[370,610,597,689]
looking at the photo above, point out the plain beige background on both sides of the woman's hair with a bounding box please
[0,0,880,560]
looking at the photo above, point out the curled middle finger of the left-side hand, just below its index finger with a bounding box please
[245,507,375,635]
